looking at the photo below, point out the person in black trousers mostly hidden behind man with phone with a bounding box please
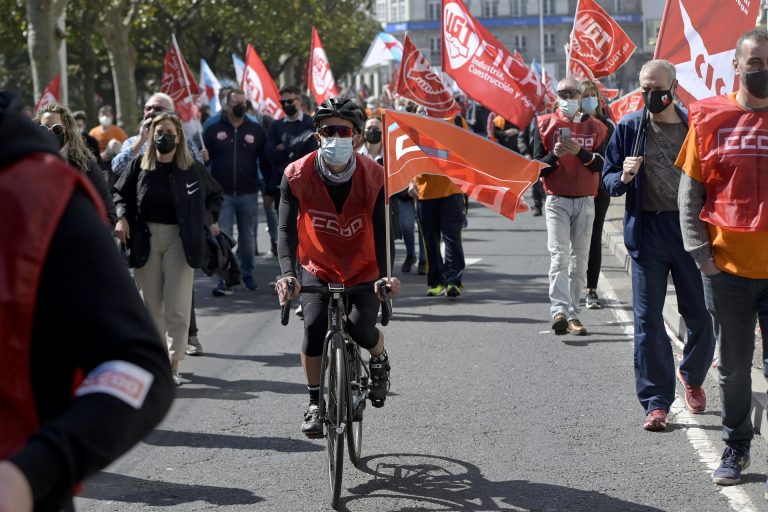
[579,80,616,309]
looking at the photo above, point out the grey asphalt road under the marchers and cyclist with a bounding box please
[77,200,768,512]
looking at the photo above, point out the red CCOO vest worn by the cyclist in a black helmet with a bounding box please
[285,151,384,286]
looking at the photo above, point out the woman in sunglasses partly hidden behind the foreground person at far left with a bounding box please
[35,103,117,225]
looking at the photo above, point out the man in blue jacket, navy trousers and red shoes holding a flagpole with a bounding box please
[603,60,715,431]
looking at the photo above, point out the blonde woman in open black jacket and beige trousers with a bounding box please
[114,113,223,385]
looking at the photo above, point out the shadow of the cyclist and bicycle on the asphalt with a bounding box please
[340,453,661,512]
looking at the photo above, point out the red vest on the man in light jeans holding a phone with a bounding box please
[536,110,608,197]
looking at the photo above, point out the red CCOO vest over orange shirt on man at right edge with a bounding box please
[690,95,768,231]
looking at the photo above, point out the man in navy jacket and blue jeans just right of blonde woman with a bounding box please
[203,89,271,297]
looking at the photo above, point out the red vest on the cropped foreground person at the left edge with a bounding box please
[0,153,106,460]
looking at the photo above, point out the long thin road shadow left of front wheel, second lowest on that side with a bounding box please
[144,430,325,453]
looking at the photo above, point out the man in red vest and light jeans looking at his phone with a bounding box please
[531,78,608,336]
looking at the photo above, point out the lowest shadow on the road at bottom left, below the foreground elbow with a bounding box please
[79,471,264,507]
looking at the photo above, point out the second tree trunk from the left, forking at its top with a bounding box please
[96,0,139,133]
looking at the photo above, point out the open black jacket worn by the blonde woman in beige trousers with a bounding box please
[114,155,224,268]
